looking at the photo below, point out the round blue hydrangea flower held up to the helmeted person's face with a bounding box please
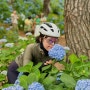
[48,44,66,61]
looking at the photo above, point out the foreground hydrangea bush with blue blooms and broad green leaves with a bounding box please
[2,44,90,90]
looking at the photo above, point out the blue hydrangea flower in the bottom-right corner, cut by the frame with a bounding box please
[75,79,90,90]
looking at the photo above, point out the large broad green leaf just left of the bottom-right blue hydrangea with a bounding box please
[60,73,76,88]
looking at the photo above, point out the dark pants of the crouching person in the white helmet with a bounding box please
[7,61,19,84]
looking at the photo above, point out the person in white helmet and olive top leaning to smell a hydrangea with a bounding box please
[7,22,63,84]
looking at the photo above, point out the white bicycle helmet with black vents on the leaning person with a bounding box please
[39,22,60,37]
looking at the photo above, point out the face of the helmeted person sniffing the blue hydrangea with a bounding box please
[43,37,58,51]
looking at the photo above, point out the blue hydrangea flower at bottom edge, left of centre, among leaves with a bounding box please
[28,82,45,90]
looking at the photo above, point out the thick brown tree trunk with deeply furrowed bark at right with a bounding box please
[64,0,90,59]
